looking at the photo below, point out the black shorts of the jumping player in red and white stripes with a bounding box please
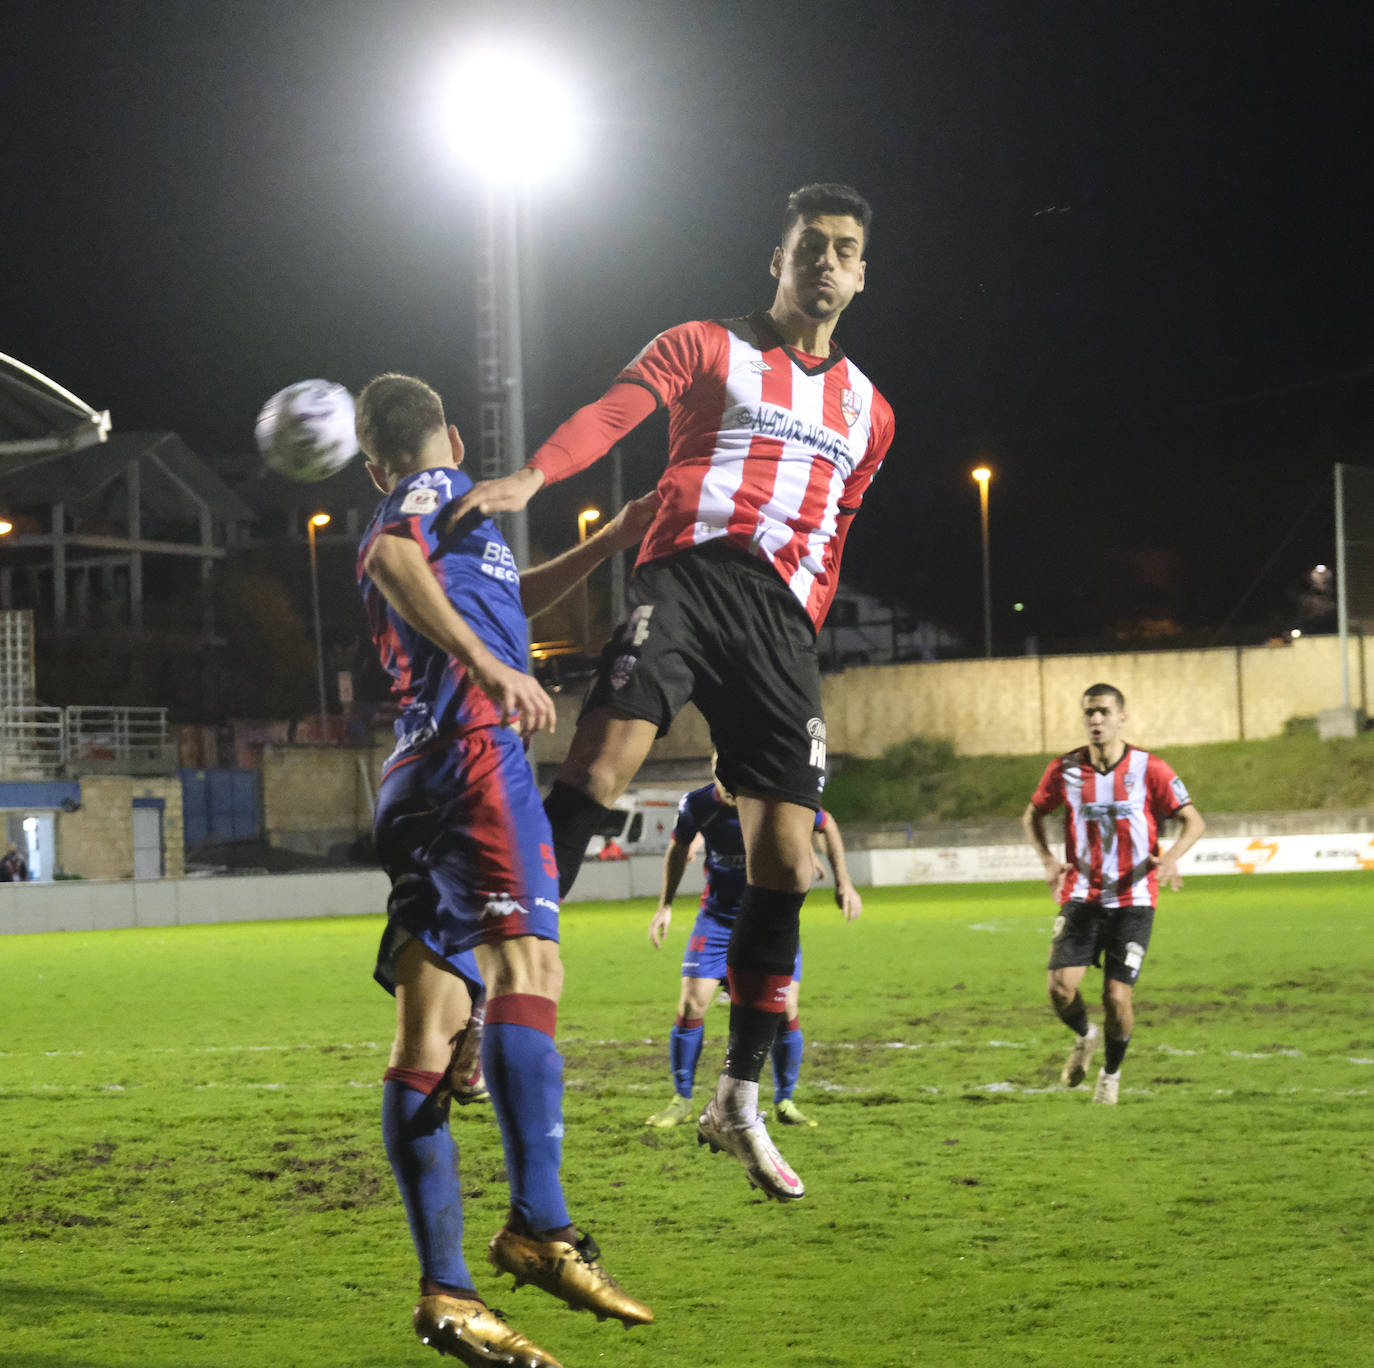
[583,541,826,810]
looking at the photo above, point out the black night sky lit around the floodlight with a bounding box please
[0,0,1374,650]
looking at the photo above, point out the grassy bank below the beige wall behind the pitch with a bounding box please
[826,731,1374,821]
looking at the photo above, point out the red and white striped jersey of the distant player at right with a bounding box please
[1031,746,1193,908]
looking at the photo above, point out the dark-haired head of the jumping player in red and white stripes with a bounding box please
[769,184,872,323]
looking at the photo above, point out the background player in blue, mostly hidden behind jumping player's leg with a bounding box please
[646,779,863,1126]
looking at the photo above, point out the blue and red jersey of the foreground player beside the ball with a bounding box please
[357,466,529,760]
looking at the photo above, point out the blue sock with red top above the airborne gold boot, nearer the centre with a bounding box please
[482,993,573,1233]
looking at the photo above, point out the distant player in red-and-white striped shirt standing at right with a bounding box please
[1022,684,1206,1106]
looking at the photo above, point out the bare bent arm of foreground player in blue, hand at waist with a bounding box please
[364,534,558,736]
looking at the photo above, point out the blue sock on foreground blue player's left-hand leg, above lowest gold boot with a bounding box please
[382,1070,473,1290]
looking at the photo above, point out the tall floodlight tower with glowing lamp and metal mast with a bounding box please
[447,44,580,570]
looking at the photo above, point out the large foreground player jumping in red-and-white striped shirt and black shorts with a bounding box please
[456,184,893,1199]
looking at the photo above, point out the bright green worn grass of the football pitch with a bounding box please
[0,875,1374,1368]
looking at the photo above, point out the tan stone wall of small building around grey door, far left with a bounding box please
[56,775,185,879]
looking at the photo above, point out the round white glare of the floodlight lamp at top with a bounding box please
[444,43,583,183]
